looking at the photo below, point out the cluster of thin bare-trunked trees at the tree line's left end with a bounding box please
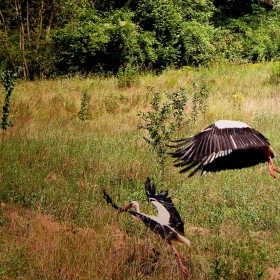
[0,0,87,80]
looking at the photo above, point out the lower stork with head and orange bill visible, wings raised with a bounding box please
[103,178,191,276]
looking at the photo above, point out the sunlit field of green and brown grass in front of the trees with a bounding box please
[0,64,280,280]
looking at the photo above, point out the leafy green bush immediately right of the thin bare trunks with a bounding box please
[51,10,110,73]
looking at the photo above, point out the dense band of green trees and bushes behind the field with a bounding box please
[0,0,280,79]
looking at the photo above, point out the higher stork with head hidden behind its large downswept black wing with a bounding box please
[169,120,280,179]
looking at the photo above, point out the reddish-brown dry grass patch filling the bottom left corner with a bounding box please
[0,204,190,279]
